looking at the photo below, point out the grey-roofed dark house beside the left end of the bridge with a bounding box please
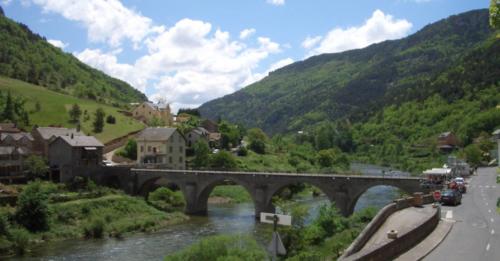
[49,135,104,169]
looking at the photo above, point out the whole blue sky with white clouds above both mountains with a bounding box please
[0,0,489,110]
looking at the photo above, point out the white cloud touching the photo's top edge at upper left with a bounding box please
[28,0,163,46]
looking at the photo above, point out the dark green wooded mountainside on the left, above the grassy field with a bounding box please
[0,7,147,104]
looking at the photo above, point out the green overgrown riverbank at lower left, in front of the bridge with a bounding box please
[0,182,188,256]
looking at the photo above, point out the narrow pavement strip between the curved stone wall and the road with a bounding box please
[395,218,455,261]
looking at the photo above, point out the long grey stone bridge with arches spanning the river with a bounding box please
[74,167,426,217]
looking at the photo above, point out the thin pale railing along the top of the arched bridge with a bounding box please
[131,168,423,180]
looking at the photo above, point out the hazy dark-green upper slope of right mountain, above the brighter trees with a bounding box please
[200,9,499,133]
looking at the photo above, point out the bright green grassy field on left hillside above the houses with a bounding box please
[0,77,144,143]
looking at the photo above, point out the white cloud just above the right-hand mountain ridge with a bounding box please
[303,10,412,56]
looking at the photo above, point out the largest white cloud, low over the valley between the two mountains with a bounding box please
[71,15,281,111]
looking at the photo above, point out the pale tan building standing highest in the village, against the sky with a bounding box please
[132,102,174,126]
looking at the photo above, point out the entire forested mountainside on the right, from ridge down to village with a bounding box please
[199,10,500,172]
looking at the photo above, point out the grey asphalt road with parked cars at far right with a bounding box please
[424,168,500,261]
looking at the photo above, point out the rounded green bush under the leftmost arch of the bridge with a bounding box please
[148,188,185,212]
